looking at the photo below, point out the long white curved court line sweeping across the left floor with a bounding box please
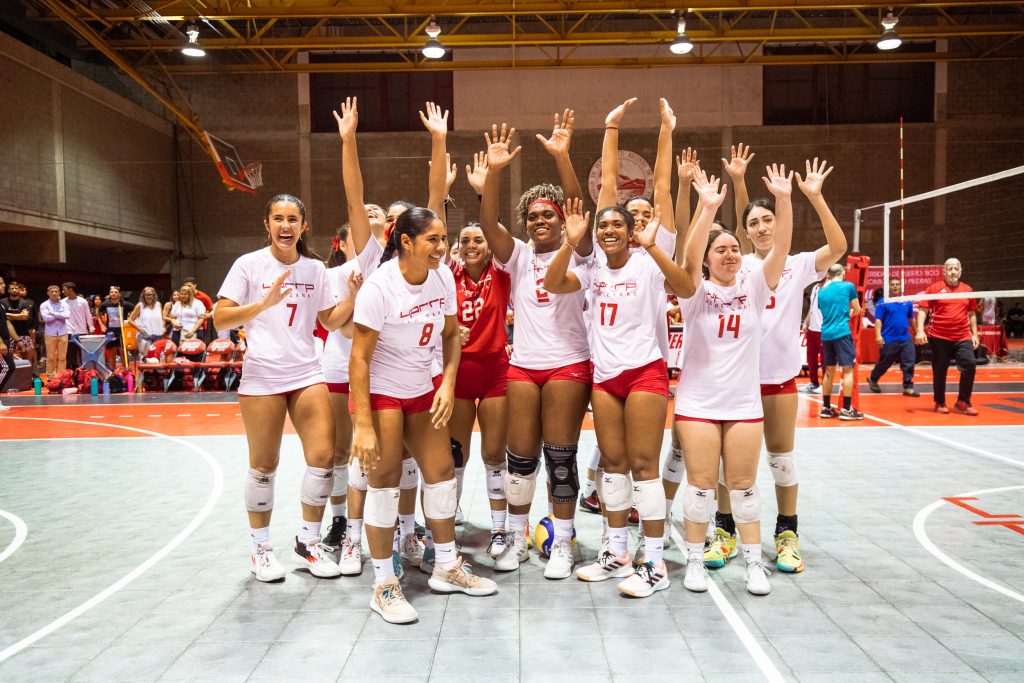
[0,417,224,661]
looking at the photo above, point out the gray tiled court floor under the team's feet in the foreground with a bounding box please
[0,413,1024,683]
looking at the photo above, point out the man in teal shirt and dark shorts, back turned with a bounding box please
[818,263,864,420]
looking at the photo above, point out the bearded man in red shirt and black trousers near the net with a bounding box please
[914,258,980,416]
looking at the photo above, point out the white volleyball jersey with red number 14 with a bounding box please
[675,268,771,420]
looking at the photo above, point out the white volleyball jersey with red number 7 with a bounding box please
[217,247,334,396]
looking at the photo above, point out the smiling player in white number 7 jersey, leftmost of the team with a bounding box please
[214,195,356,582]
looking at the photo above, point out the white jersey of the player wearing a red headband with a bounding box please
[495,240,591,370]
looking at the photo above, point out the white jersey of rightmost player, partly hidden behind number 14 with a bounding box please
[740,252,824,384]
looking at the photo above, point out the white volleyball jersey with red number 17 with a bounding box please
[572,252,668,383]
